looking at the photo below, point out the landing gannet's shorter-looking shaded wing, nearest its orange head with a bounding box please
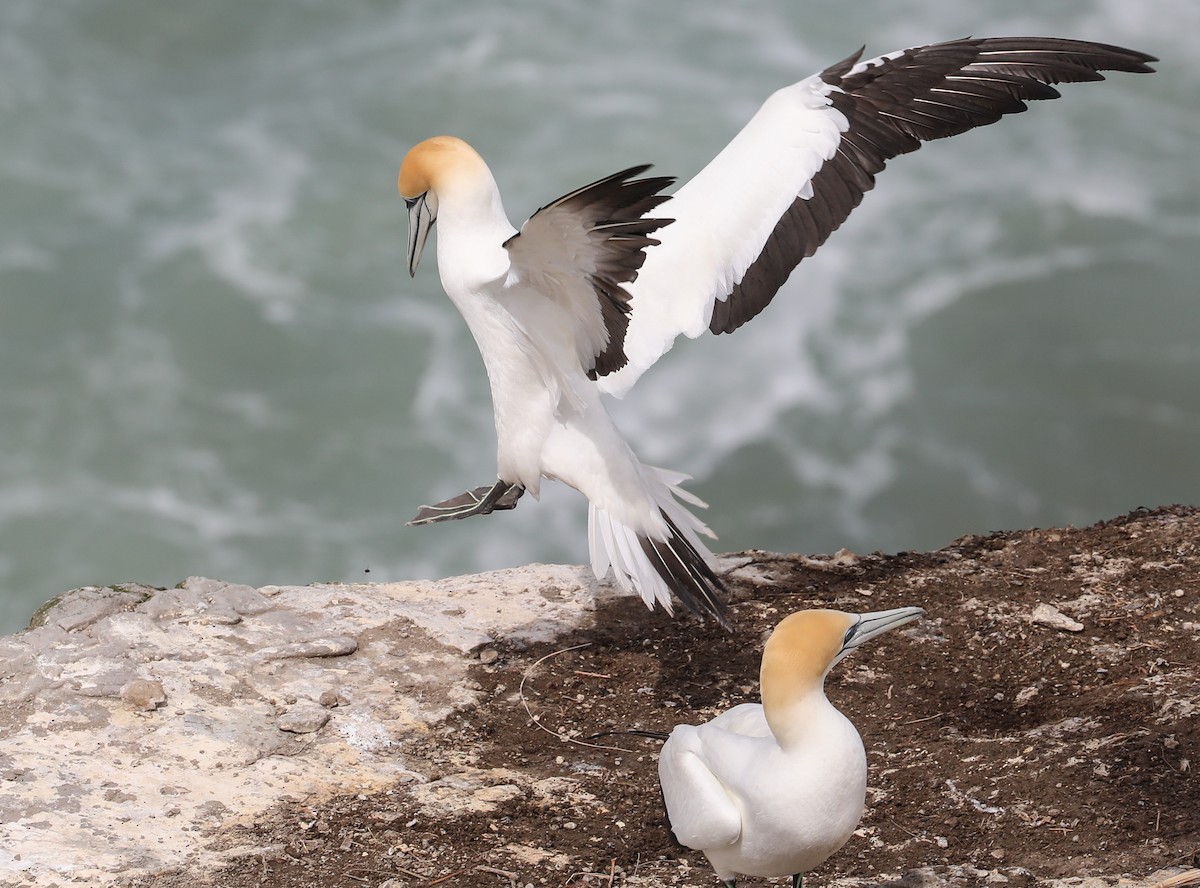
[504,166,674,379]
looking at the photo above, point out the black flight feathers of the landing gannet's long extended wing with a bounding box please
[708,37,1158,334]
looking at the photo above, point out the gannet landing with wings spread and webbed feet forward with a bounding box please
[398,37,1154,625]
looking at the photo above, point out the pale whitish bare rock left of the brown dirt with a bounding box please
[0,565,596,886]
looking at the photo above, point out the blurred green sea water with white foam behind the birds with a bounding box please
[0,0,1200,631]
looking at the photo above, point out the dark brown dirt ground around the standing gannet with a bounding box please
[142,506,1200,888]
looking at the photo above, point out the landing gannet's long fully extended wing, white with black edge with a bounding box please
[600,37,1154,395]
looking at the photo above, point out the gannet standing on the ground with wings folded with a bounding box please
[659,607,924,888]
